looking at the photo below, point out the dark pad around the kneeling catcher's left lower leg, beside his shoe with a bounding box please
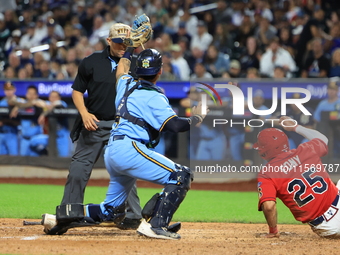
[56,203,85,224]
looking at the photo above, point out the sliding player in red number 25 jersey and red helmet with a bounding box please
[254,116,340,238]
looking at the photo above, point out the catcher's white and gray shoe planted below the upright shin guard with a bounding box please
[137,219,181,240]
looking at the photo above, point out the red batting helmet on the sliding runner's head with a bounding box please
[253,128,289,161]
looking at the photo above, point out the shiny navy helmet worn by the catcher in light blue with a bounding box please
[135,49,163,76]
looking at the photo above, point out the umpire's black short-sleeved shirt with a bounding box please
[72,46,120,120]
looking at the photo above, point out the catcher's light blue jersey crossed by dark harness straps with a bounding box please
[111,75,176,142]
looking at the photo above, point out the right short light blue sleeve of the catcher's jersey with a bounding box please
[144,92,177,131]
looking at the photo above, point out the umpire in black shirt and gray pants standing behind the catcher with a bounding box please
[45,23,142,232]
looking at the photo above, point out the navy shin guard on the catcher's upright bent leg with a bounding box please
[147,165,192,228]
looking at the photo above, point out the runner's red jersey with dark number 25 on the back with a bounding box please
[258,139,338,223]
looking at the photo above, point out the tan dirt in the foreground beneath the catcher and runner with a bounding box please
[0,219,339,255]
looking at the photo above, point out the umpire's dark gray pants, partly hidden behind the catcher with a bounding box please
[61,120,142,219]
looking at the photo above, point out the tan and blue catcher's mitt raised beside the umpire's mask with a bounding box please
[123,14,153,48]
